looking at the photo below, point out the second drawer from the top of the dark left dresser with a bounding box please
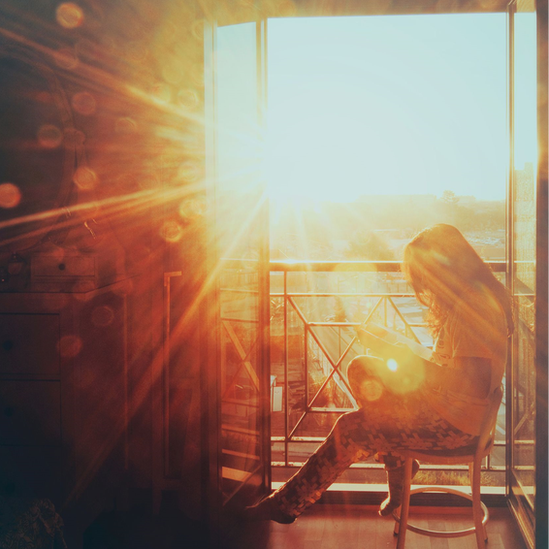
[0,380,61,446]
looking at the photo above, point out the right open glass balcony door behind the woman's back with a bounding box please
[508,0,537,547]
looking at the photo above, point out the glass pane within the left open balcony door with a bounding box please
[215,23,263,502]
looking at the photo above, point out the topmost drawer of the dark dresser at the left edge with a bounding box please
[0,313,59,375]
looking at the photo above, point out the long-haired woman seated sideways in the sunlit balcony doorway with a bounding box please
[246,224,513,524]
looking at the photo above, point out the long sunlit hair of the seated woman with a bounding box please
[402,223,514,336]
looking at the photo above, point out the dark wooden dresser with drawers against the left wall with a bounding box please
[0,283,128,535]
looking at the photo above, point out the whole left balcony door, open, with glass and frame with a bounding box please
[206,15,270,508]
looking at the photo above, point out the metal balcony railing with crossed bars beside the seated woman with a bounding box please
[270,261,506,486]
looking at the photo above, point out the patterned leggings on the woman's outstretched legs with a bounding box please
[271,357,478,517]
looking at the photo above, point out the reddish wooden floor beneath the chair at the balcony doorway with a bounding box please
[224,504,526,549]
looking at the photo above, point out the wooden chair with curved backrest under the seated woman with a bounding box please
[393,387,503,549]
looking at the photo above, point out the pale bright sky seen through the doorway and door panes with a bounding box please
[213,14,535,206]
